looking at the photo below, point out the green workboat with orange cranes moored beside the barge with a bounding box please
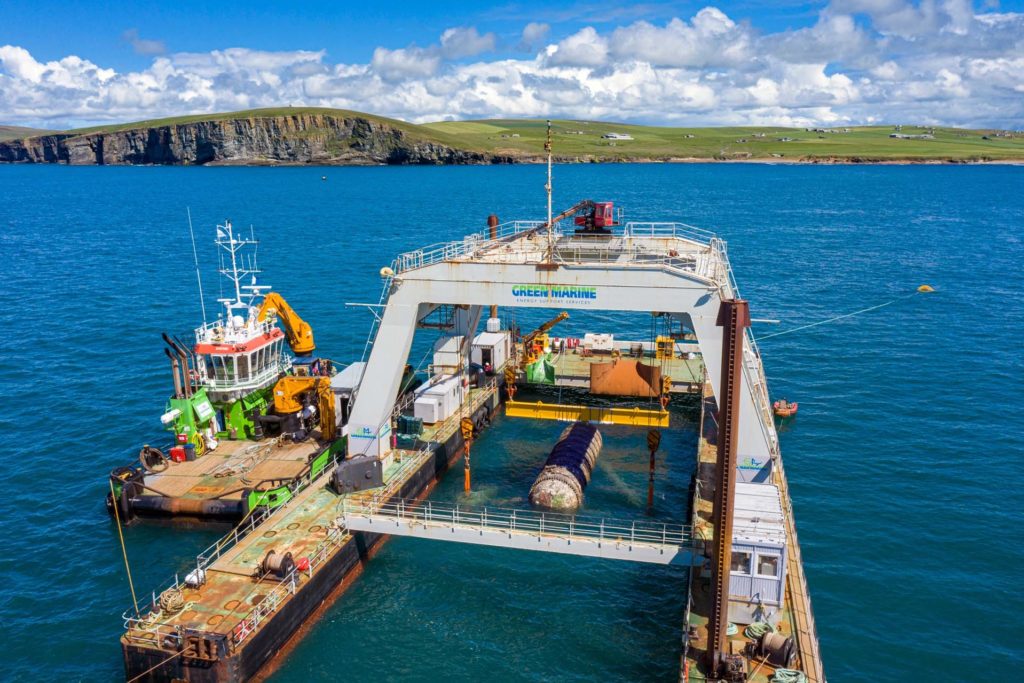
[106,221,358,522]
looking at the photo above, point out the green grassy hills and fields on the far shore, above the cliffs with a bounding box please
[0,106,1024,162]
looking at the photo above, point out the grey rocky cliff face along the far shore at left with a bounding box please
[0,114,512,166]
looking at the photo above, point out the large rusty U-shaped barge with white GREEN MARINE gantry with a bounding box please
[121,189,824,683]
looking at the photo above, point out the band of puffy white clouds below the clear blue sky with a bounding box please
[0,0,1024,128]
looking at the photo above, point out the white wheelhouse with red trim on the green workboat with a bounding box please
[195,312,292,402]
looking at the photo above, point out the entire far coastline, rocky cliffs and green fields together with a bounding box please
[0,111,1024,166]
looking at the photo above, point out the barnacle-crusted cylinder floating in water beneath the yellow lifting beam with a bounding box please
[529,422,601,510]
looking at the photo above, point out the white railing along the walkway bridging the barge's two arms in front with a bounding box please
[342,499,693,546]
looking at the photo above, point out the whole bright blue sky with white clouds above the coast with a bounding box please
[0,0,1024,129]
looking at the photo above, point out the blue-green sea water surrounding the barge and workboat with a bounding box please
[0,165,1024,681]
